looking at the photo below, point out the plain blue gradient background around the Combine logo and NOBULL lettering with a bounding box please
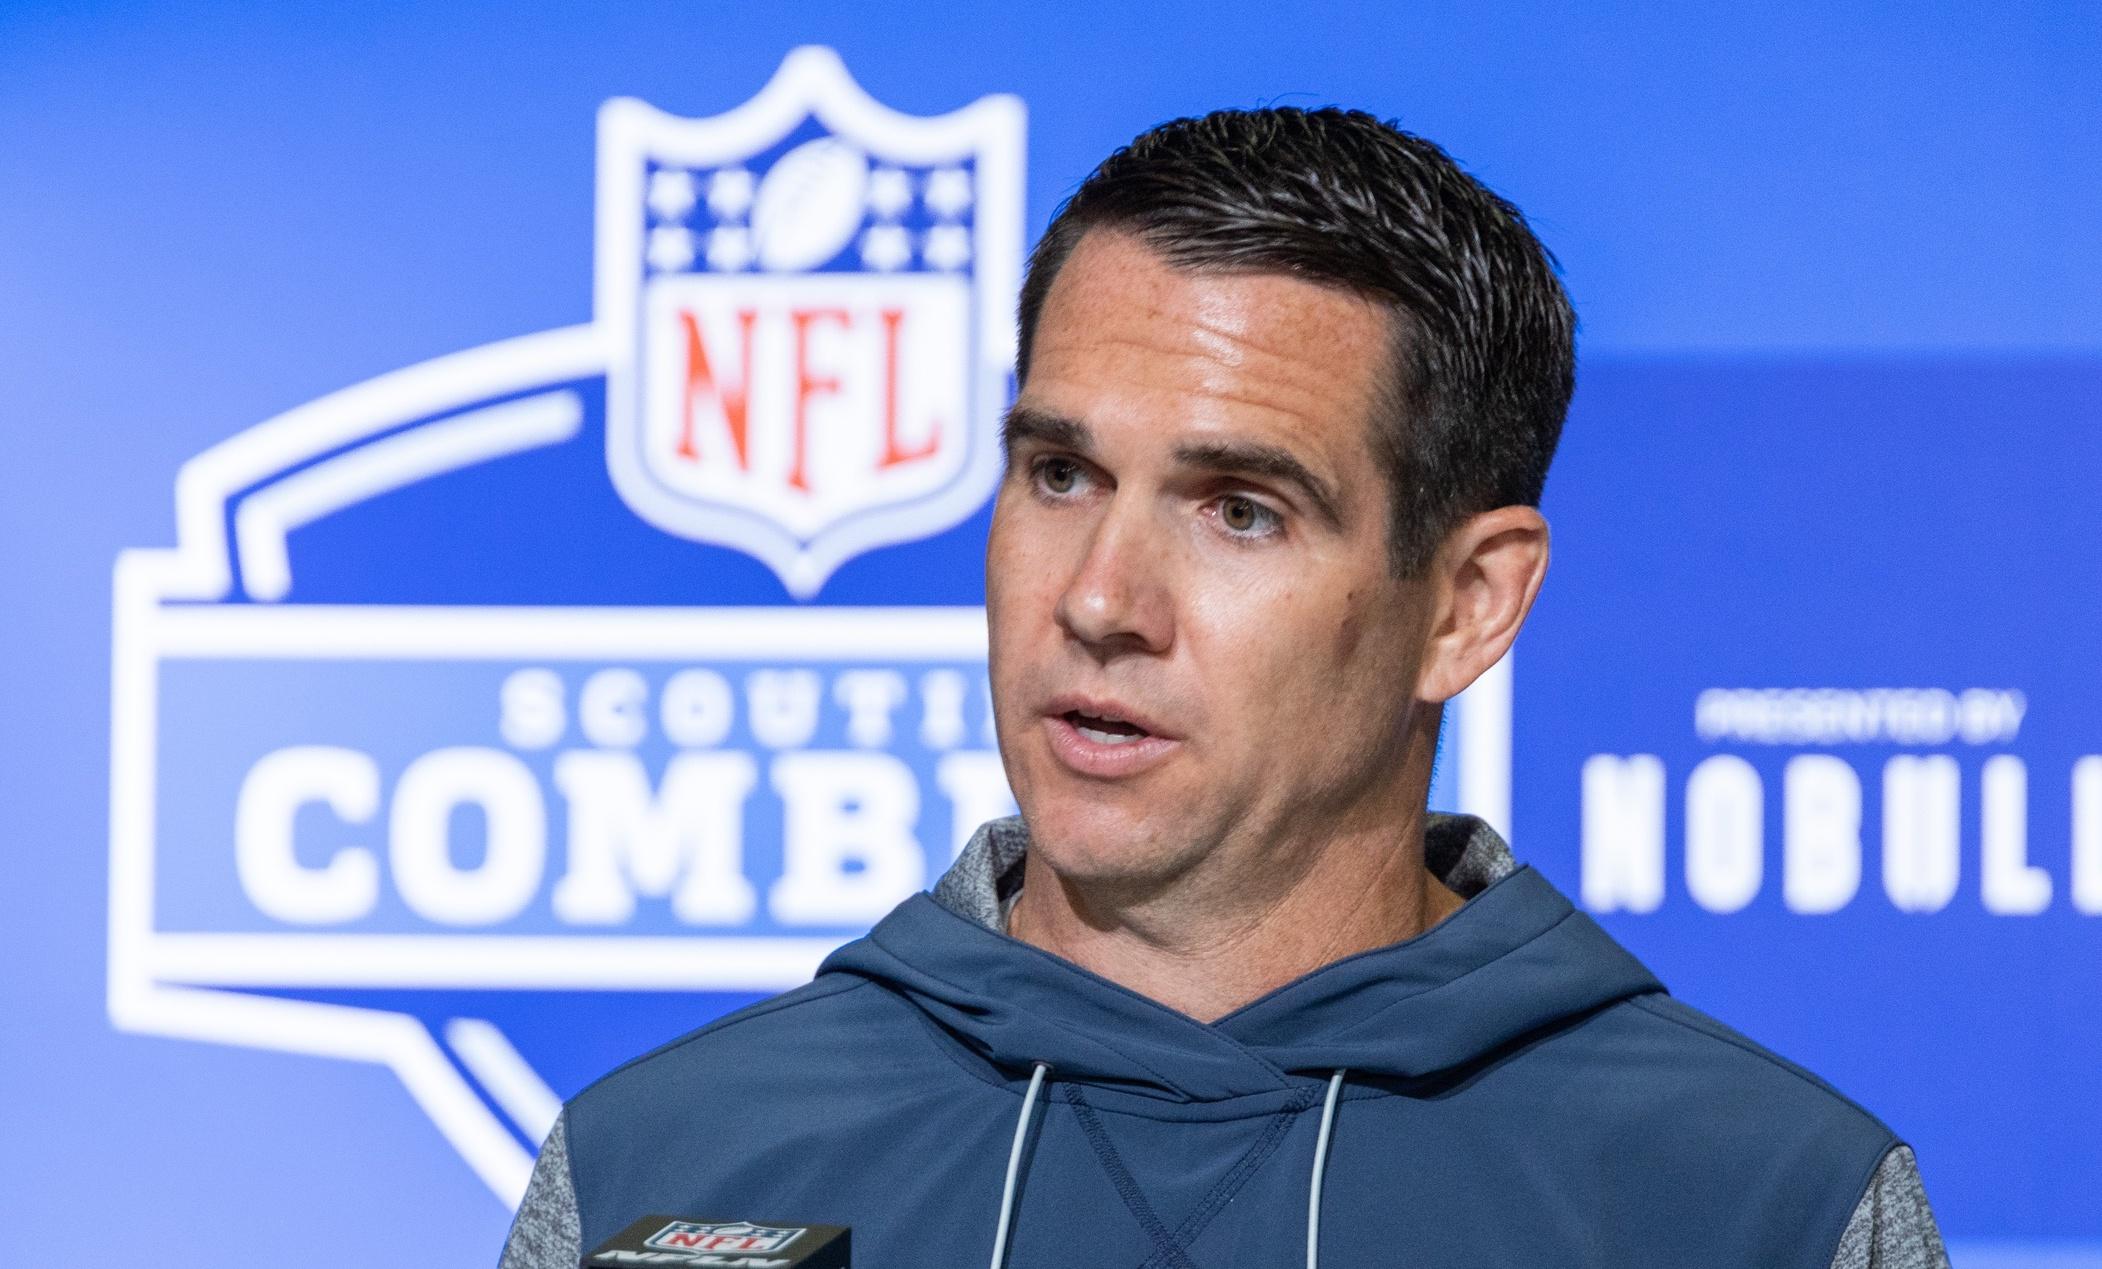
[0,0,2102,1269]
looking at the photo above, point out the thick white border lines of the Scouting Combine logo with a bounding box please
[107,48,1511,1206]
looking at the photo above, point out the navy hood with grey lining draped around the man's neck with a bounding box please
[822,817,1663,1101]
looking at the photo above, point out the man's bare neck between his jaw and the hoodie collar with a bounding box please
[1007,811,1463,1023]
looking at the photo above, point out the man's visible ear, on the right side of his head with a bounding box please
[1417,506,1547,704]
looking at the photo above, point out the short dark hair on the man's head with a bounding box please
[1017,107,1577,576]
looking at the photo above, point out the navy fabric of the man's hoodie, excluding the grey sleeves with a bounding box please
[565,819,1894,1269]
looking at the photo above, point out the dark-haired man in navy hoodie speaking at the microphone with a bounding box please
[504,109,1946,1269]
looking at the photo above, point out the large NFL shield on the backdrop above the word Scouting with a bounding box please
[597,48,1024,599]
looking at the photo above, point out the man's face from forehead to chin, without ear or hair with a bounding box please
[986,231,1425,887]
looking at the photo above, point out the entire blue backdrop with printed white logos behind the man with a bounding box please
[0,0,2102,1269]
